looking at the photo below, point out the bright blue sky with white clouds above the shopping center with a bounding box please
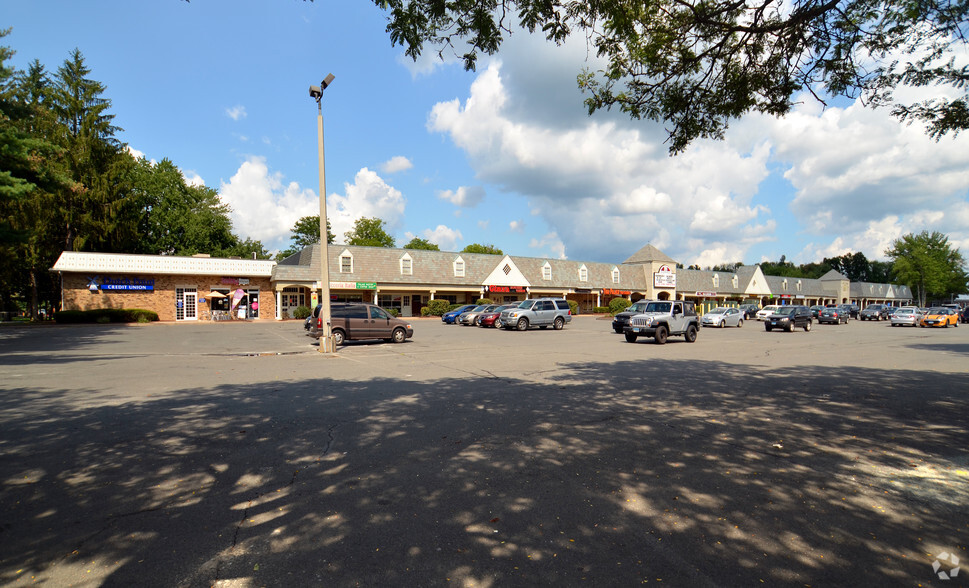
[0,0,969,266]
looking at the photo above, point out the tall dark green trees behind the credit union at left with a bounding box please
[0,34,268,317]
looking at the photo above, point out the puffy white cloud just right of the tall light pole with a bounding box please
[326,168,407,243]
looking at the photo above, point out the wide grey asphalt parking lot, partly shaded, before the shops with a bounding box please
[0,316,969,587]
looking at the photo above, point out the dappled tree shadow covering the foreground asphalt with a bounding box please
[0,358,969,586]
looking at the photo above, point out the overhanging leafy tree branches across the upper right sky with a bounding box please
[374,0,969,153]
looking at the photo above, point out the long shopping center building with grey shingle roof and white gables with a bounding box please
[52,244,912,321]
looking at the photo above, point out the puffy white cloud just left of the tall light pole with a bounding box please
[219,156,320,249]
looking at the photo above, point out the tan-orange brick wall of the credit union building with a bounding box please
[63,273,276,321]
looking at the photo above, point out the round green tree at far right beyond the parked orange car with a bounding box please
[885,231,969,306]
